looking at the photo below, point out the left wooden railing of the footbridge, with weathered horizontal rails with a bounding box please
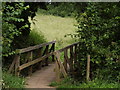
[8,41,56,76]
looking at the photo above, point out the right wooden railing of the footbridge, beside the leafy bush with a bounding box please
[54,42,80,82]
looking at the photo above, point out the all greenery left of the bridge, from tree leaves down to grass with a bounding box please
[2,2,45,88]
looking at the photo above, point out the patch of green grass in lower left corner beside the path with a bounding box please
[2,72,25,88]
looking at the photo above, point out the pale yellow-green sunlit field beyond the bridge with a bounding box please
[31,13,76,49]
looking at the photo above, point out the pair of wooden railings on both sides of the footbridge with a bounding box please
[8,41,90,87]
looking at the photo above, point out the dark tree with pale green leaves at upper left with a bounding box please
[2,2,45,59]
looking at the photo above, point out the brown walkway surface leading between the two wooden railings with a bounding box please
[26,63,55,90]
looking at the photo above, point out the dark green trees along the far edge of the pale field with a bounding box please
[40,2,76,17]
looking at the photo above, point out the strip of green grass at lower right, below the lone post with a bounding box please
[50,78,120,89]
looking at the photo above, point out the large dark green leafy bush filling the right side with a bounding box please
[76,3,120,80]
